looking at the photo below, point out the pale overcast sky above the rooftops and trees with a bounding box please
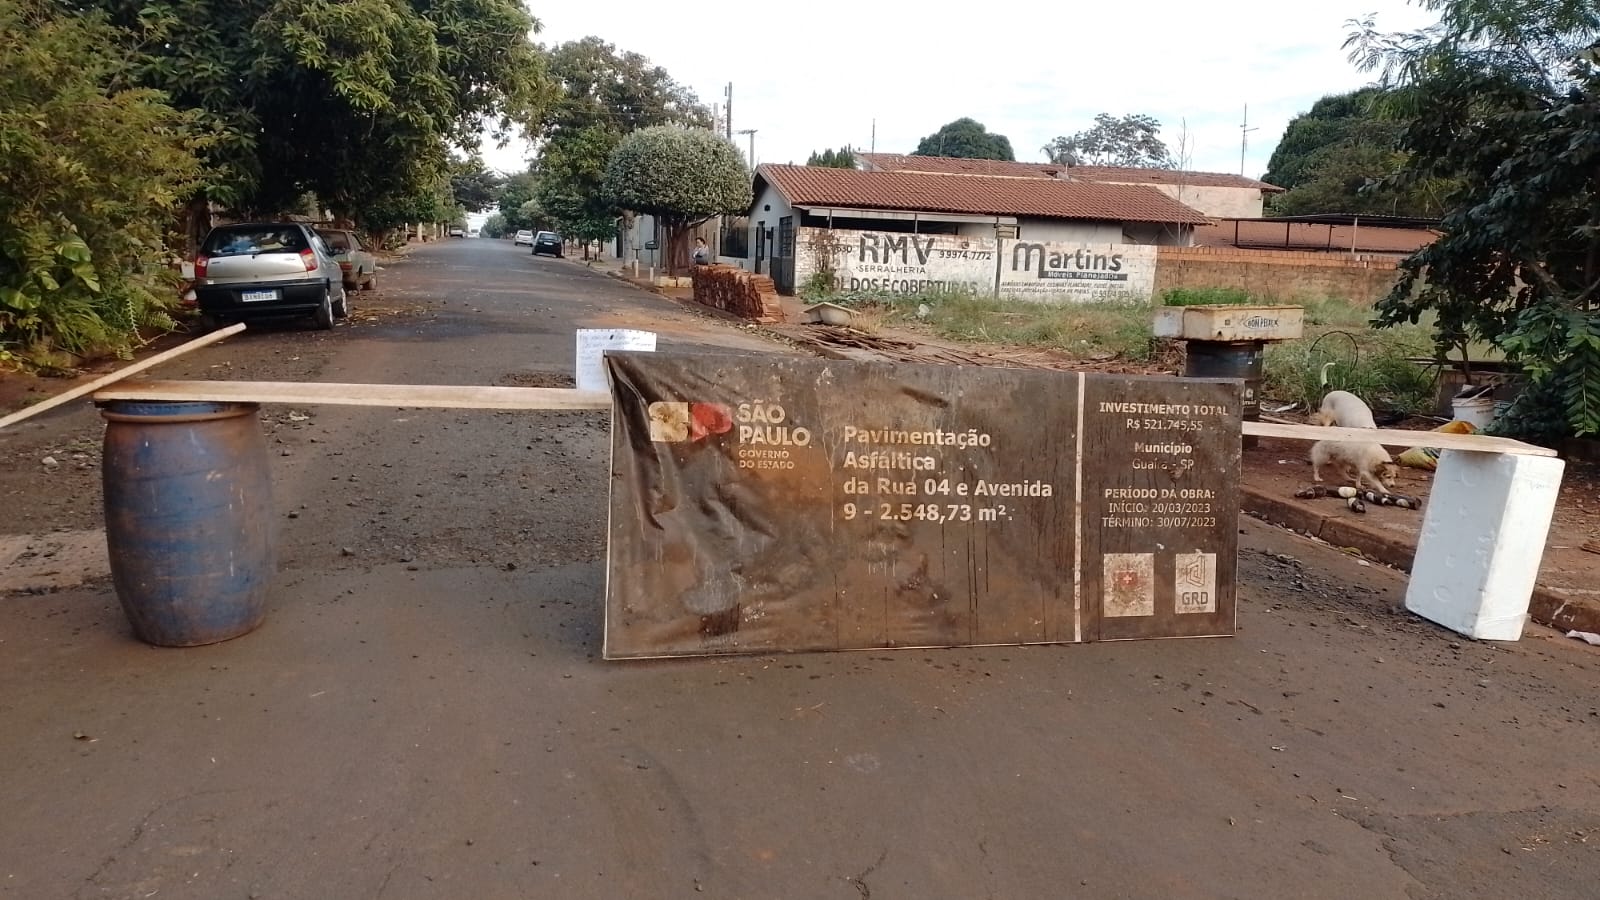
[485,0,1434,176]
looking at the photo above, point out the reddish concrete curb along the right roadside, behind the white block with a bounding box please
[1240,487,1600,633]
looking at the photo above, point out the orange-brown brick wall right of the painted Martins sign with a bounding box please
[1155,247,1402,303]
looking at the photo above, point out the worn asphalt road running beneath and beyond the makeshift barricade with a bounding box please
[0,240,1600,900]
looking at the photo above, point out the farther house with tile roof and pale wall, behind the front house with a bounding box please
[856,154,1283,218]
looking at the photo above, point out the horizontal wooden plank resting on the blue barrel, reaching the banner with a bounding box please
[94,381,611,410]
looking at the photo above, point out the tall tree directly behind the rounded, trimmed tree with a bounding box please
[536,37,712,258]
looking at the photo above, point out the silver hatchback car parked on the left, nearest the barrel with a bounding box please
[194,223,350,330]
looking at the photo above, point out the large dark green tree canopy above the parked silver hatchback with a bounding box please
[95,0,549,235]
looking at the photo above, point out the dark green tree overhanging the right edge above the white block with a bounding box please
[1346,0,1600,439]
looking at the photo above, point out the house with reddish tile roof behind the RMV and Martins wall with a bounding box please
[739,160,1211,293]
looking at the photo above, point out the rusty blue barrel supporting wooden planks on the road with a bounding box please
[101,400,277,647]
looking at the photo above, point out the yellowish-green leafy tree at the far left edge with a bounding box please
[0,0,205,365]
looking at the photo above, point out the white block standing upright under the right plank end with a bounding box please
[1405,450,1566,641]
